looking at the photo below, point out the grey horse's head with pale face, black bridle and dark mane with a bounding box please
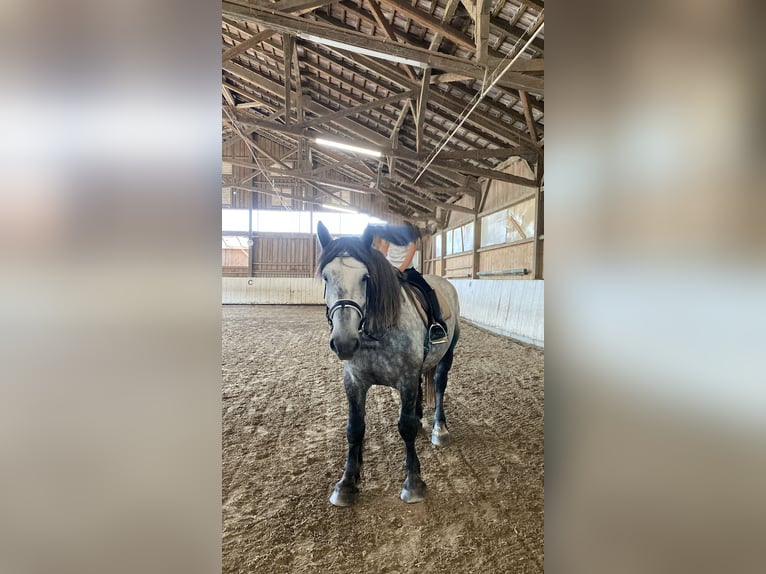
[317,221,412,361]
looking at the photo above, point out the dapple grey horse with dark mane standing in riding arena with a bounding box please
[317,222,460,506]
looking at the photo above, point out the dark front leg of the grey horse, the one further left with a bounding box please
[330,373,367,506]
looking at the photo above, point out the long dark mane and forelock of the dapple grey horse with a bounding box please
[317,237,402,338]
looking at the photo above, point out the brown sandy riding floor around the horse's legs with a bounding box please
[223,305,543,574]
